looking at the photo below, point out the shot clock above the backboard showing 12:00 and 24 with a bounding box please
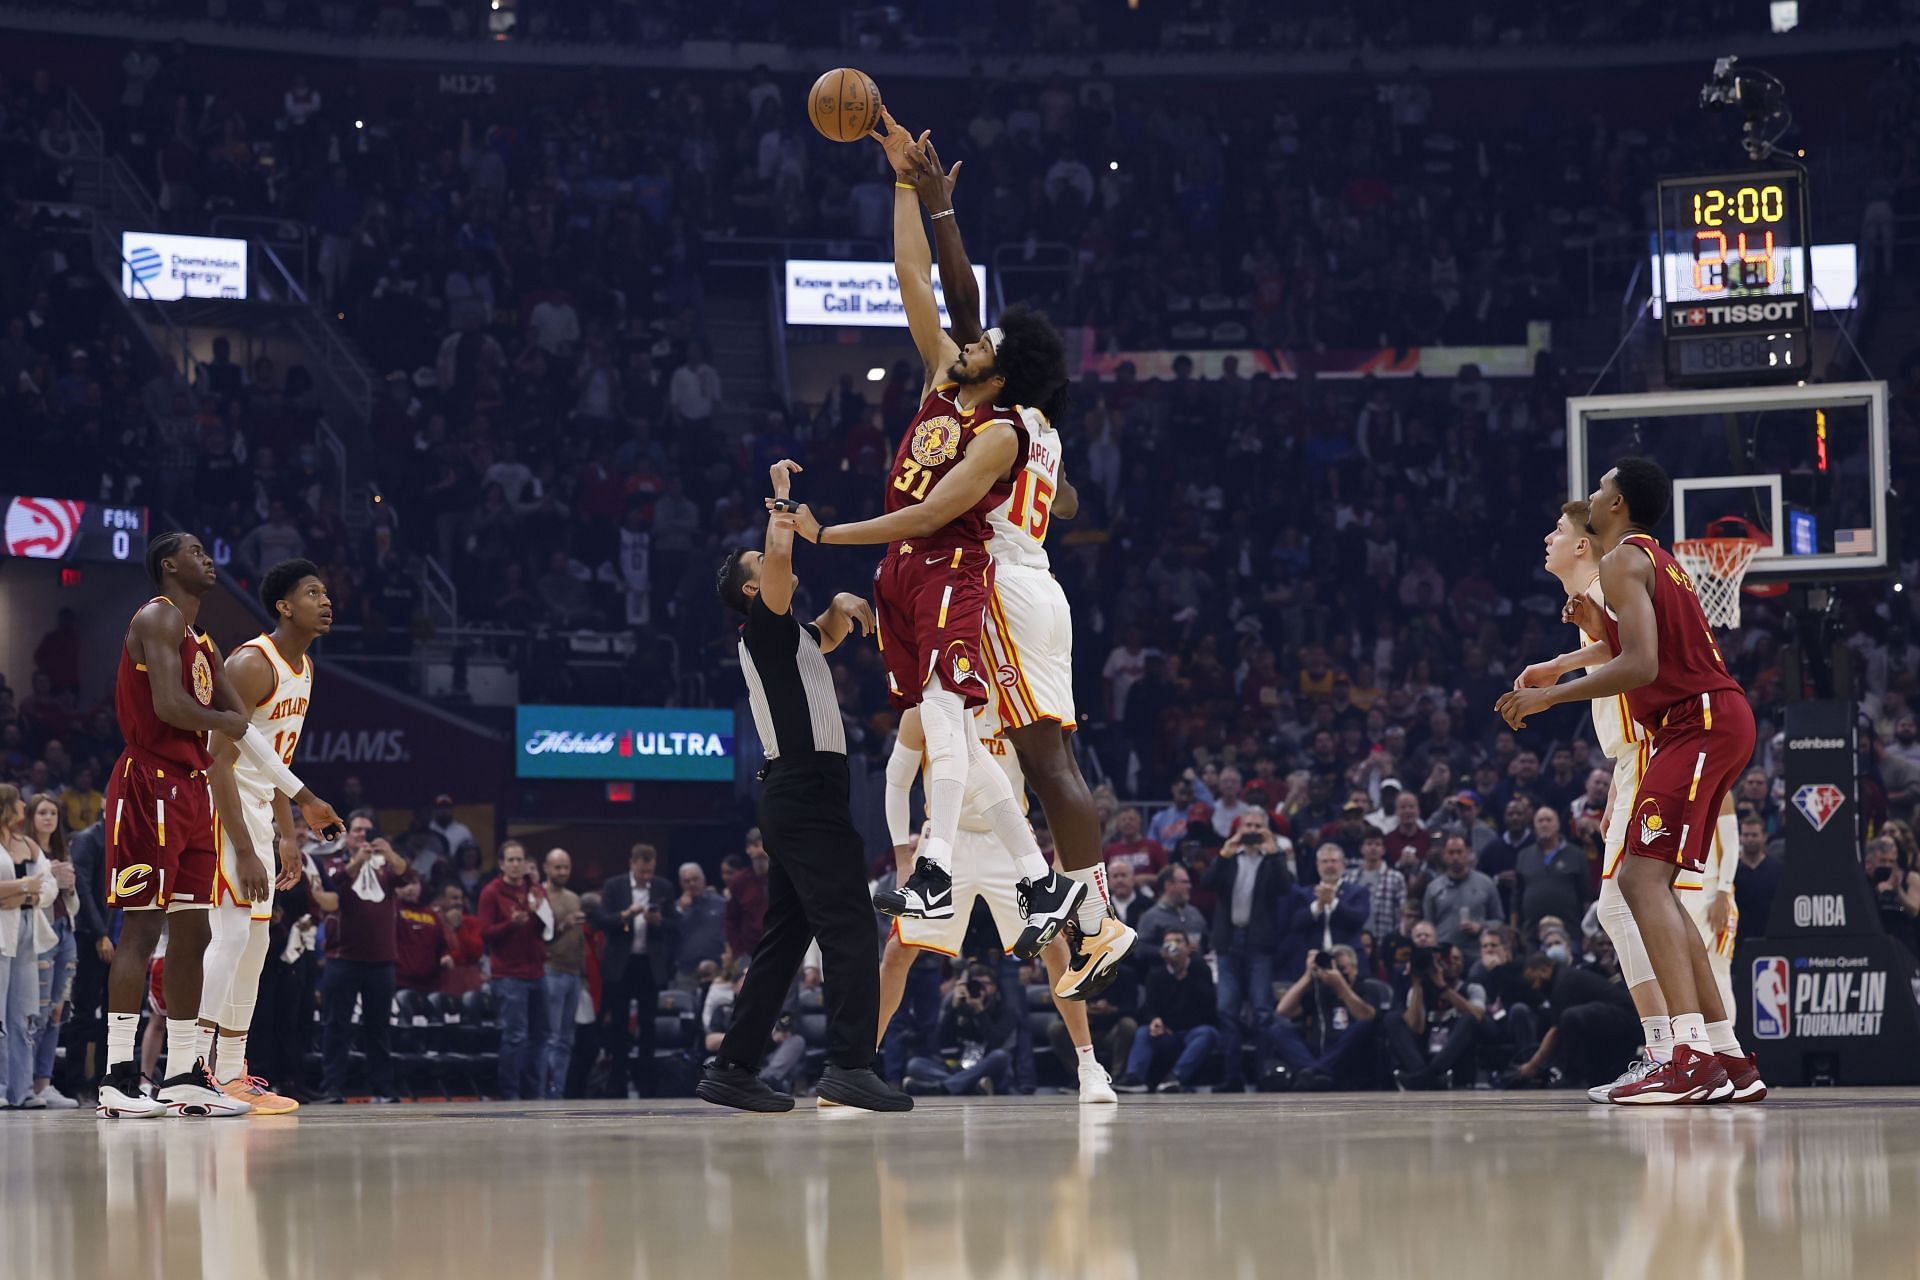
[1655,169,1812,386]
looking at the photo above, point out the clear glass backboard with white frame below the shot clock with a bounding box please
[1567,382,1889,580]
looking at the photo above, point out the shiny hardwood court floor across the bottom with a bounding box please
[0,1090,1920,1280]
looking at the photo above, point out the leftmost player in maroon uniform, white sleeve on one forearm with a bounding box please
[98,533,340,1119]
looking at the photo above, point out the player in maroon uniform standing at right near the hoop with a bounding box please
[1496,459,1766,1105]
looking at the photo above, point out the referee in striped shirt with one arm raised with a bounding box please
[695,459,914,1111]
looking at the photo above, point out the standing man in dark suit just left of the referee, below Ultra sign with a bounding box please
[593,844,679,1098]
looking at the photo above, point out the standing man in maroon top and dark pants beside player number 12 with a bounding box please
[321,825,407,1103]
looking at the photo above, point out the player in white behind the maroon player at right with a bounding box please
[1513,499,1740,1102]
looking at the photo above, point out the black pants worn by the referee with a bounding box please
[720,752,879,1069]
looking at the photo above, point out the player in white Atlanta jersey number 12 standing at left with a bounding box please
[200,560,334,1115]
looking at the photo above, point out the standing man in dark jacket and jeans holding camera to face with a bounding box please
[1206,808,1294,1094]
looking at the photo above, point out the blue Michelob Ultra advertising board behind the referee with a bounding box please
[515,706,733,783]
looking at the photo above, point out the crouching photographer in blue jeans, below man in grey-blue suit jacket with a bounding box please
[1260,946,1392,1092]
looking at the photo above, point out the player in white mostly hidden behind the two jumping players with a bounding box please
[879,702,1119,1103]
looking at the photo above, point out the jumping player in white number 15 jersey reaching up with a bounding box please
[902,138,1135,997]
